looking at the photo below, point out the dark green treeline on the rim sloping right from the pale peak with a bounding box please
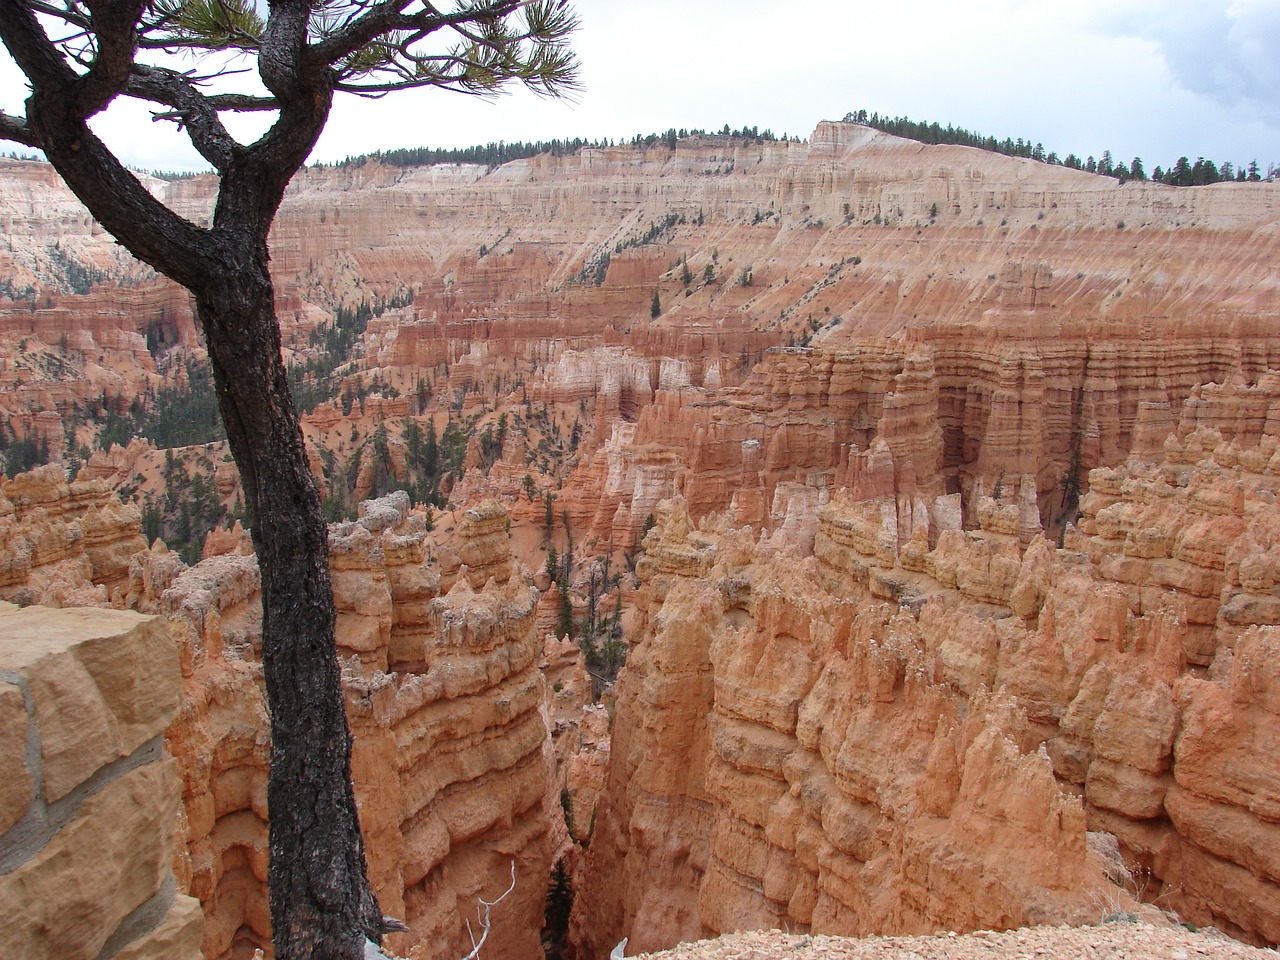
[845,110,1276,187]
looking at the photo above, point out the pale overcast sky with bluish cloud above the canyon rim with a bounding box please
[0,0,1280,172]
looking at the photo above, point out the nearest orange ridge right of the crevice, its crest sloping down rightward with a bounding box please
[576,503,1121,952]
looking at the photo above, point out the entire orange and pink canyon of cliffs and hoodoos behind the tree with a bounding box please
[0,123,1280,960]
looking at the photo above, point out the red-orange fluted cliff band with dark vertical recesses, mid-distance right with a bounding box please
[561,321,1280,555]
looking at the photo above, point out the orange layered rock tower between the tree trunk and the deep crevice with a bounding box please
[348,494,552,957]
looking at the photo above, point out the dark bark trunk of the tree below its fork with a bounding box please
[196,237,381,960]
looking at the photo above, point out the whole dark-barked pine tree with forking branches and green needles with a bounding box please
[0,0,576,960]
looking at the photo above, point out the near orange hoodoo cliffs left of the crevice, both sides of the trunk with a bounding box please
[3,466,562,960]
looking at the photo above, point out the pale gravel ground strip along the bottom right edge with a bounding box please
[640,923,1280,960]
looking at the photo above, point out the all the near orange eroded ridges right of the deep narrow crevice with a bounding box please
[575,407,1280,954]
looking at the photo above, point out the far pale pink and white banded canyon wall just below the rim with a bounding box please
[0,123,1280,488]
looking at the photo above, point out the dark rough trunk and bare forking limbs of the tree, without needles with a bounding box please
[0,0,381,960]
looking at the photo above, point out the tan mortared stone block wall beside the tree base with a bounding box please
[0,603,202,960]
